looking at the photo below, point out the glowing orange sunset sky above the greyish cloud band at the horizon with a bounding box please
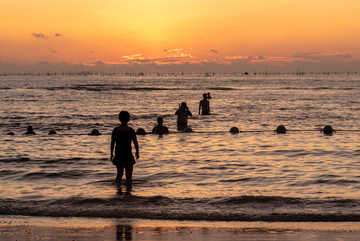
[0,0,360,71]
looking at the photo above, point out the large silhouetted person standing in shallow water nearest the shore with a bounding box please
[110,111,139,188]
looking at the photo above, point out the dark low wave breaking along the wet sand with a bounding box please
[0,194,360,222]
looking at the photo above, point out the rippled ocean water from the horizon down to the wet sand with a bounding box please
[0,74,360,222]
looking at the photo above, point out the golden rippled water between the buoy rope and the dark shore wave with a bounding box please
[0,132,360,199]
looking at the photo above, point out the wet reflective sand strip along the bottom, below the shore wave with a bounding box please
[0,216,360,241]
